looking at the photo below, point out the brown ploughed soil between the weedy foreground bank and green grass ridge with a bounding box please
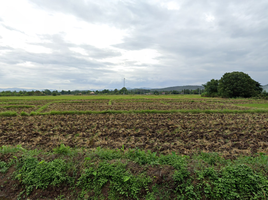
[0,114,268,157]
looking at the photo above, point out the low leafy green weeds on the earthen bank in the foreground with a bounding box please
[0,145,268,200]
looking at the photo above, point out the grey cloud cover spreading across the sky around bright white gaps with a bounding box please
[0,0,268,88]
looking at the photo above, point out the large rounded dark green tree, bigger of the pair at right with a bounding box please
[218,72,262,98]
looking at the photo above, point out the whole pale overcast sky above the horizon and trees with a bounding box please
[0,0,268,90]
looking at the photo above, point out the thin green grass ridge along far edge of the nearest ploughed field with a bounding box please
[0,109,268,116]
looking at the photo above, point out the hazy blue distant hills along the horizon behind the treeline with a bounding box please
[0,84,268,92]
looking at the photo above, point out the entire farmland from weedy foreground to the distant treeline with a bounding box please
[0,95,268,199]
